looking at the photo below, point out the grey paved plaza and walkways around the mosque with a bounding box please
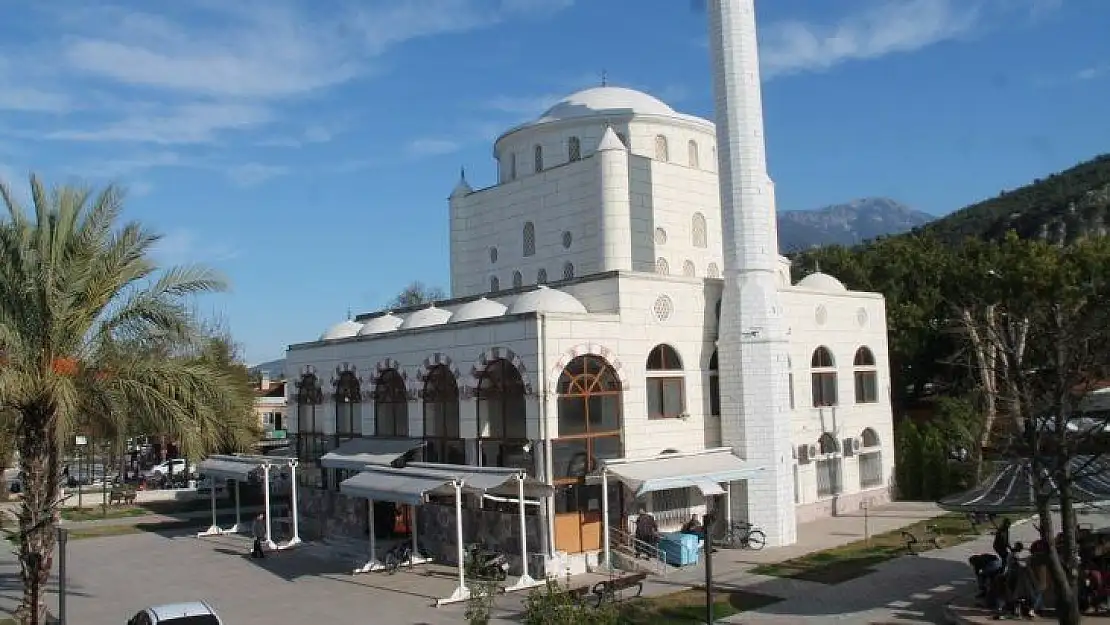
[0,503,1110,625]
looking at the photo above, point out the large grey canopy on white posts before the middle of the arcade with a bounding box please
[340,462,548,606]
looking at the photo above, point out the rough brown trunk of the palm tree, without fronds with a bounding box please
[17,407,60,625]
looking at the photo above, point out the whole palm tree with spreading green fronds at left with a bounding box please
[0,175,254,625]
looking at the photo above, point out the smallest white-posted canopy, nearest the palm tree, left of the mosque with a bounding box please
[196,454,301,550]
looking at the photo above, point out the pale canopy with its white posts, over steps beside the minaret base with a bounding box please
[592,447,763,568]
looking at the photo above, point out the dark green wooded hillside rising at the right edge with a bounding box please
[921,154,1110,243]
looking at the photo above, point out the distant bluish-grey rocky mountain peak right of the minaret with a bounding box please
[778,198,936,254]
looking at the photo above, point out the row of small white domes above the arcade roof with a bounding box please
[320,286,588,341]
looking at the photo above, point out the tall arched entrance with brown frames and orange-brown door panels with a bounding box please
[552,355,624,553]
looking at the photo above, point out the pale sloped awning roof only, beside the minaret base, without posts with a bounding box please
[601,447,763,497]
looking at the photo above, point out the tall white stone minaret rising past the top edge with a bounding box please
[708,0,797,546]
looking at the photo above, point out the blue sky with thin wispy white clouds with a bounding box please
[0,0,1110,362]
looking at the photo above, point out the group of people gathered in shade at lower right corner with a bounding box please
[968,518,1110,618]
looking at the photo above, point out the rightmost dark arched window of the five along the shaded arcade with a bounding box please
[477,359,533,470]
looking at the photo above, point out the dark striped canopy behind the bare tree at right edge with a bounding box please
[937,456,1110,514]
